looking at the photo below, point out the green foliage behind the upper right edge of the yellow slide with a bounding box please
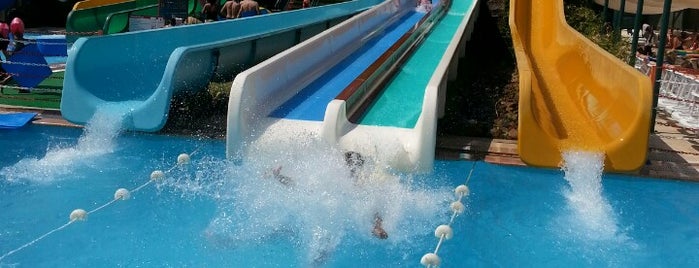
[565,0,631,61]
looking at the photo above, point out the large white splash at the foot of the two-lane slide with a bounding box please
[158,134,453,267]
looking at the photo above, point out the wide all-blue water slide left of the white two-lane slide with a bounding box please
[61,0,381,132]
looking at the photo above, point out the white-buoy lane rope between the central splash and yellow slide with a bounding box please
[420,161,477,267]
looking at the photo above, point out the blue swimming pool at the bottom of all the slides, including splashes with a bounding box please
[0,123,699,267]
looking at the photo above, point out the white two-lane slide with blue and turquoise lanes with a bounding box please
[226,0,478,172]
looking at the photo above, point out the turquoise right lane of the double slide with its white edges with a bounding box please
[323,0,479,172]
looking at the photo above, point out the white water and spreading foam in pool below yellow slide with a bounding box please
[550,151,642,267]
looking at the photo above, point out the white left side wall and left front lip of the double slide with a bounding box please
[226,0,422,158]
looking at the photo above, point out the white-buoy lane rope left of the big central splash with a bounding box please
[0,152,198,264]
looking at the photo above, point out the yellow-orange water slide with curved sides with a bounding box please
[510,0,653,172]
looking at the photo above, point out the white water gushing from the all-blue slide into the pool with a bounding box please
[0,103,131,183]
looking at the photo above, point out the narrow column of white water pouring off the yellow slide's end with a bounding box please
[563,151,619,240]
